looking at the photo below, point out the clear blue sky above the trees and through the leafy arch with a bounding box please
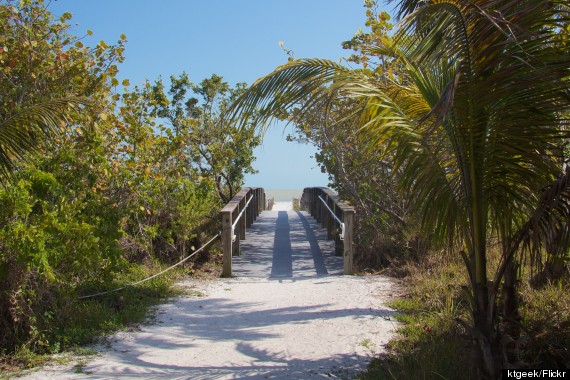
[46,0,365,188]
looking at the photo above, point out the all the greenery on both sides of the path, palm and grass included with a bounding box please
[0,0,570,378]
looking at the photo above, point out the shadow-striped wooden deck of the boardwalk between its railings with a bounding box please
[232,211,343,279]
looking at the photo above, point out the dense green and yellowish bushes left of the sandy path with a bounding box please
[0,0,259,368]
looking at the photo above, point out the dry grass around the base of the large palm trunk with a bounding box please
[360,252,570,379]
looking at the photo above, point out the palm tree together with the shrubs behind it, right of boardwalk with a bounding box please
[227,0,570,378]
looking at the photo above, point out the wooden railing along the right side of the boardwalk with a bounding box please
[300,187,355,274]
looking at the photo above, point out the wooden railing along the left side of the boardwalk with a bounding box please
[220,187,267,277]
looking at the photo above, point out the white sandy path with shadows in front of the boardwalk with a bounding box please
[23,276,395,379]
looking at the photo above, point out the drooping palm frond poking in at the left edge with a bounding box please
[0,97,89,182]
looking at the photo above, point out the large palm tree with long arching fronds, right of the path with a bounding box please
[228,0,570,378]
